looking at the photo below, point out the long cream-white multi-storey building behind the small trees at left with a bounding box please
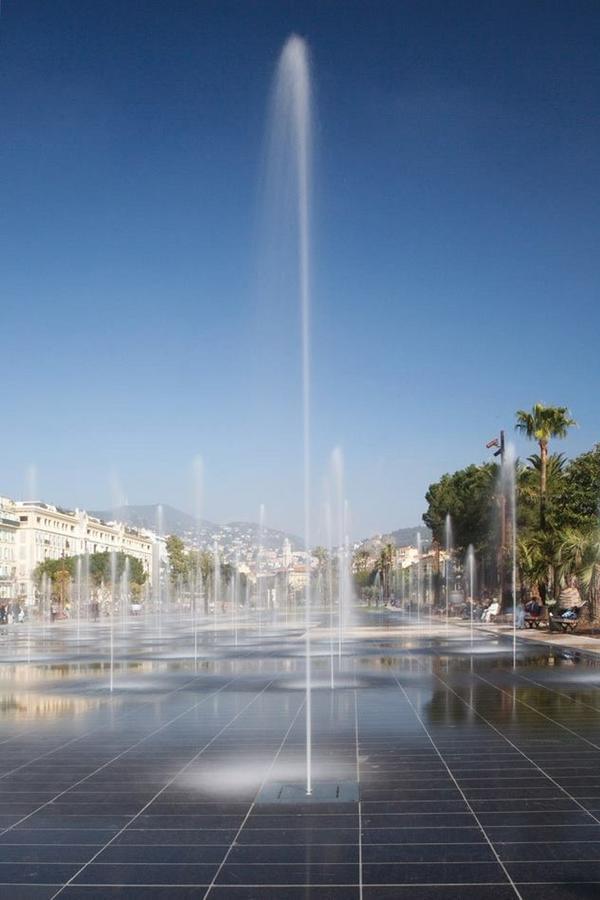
[12,500,155,604]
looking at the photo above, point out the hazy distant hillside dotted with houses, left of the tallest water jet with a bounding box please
[90,503,303,556]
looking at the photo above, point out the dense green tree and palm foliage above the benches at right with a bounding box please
[423,404,600,614]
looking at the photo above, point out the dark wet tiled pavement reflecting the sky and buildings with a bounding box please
[0,613,600,900]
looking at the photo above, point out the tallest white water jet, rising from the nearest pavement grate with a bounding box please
[270,35,312,794]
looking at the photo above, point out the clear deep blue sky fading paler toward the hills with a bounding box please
[0,0,600,535]
